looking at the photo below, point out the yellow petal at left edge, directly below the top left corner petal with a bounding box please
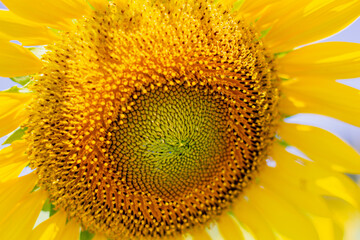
[0,10,56,46]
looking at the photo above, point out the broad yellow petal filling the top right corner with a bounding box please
[264,0,360,52]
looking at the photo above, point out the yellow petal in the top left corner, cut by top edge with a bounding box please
[2,0,90,29]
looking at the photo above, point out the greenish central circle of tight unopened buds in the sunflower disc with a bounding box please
[109,86,229,199]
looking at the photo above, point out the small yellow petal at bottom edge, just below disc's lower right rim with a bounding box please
[217,213,244,240]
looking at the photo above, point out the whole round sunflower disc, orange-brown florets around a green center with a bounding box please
[26,0,279,239]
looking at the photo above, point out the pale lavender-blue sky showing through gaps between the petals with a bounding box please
[0,1,360,152]
